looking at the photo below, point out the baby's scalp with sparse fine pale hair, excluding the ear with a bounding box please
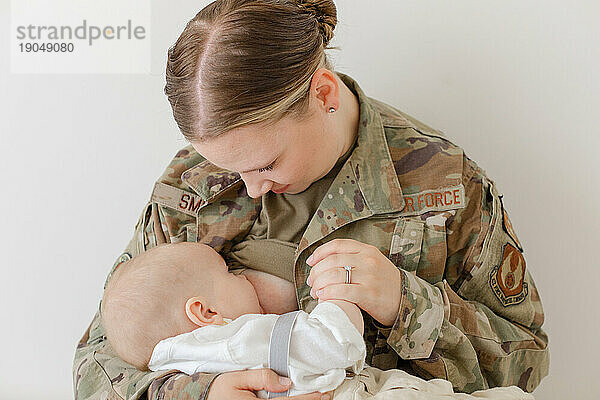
[100,244,211,371]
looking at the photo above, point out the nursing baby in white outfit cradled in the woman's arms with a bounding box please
[101,242,366,397]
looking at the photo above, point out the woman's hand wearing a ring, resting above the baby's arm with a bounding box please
[306,239,402,326]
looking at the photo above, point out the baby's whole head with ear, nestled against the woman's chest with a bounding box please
[100,242,262,370]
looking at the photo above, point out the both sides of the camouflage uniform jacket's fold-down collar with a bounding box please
[181,72,404,219]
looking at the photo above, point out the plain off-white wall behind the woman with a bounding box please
[0,0,600,400]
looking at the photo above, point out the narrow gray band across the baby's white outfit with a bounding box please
[267,311,300,399]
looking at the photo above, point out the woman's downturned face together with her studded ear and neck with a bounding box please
[192,68,359,198]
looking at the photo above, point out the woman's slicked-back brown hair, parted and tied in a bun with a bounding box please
[164,0,337,141]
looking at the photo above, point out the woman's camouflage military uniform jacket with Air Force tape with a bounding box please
[73,73,549,399]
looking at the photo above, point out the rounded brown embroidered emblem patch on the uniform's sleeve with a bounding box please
[490,243,528,307]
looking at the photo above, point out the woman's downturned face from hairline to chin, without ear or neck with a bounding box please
[192,99,344,198]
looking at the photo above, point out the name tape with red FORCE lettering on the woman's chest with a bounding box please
[400,184,465,216]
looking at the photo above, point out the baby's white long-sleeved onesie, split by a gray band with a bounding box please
[148,301,366,397]
